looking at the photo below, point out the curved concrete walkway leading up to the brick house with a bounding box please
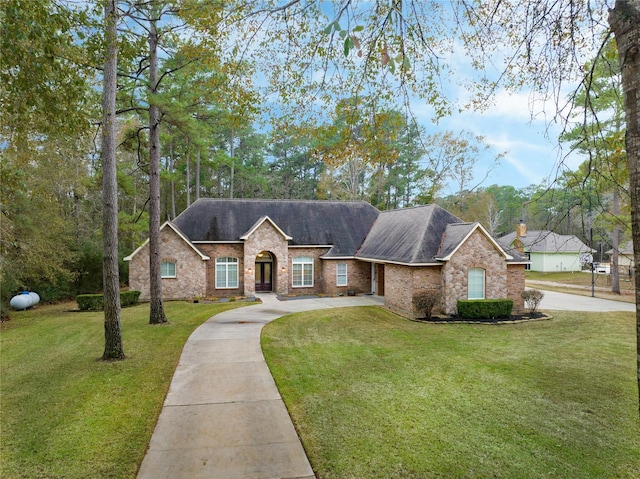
[137,294,384,479]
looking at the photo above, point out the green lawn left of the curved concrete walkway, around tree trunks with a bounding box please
[0,302,252,479]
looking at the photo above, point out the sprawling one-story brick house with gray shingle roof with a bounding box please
[125,198,526,317]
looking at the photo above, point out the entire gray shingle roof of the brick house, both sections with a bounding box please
[173,198,522,264]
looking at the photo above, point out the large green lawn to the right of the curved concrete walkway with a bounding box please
[263,307,640,479]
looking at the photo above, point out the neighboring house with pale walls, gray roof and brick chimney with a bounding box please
[498,223,595,273]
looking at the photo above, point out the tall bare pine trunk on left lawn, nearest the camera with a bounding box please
[101,0,124,360]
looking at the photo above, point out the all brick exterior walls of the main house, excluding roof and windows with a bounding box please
[129,221,525,310]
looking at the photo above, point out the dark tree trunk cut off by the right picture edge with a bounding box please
[609,0,640,410]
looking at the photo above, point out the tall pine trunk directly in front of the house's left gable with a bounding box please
[148,12,167,324]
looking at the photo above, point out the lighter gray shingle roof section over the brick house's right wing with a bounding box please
[357,205,464,264]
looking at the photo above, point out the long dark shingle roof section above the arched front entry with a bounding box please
[173,198,380,257]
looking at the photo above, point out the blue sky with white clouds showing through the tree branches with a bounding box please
[248,2,582,195]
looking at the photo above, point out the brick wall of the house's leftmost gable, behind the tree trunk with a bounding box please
[129,227,211,301]
